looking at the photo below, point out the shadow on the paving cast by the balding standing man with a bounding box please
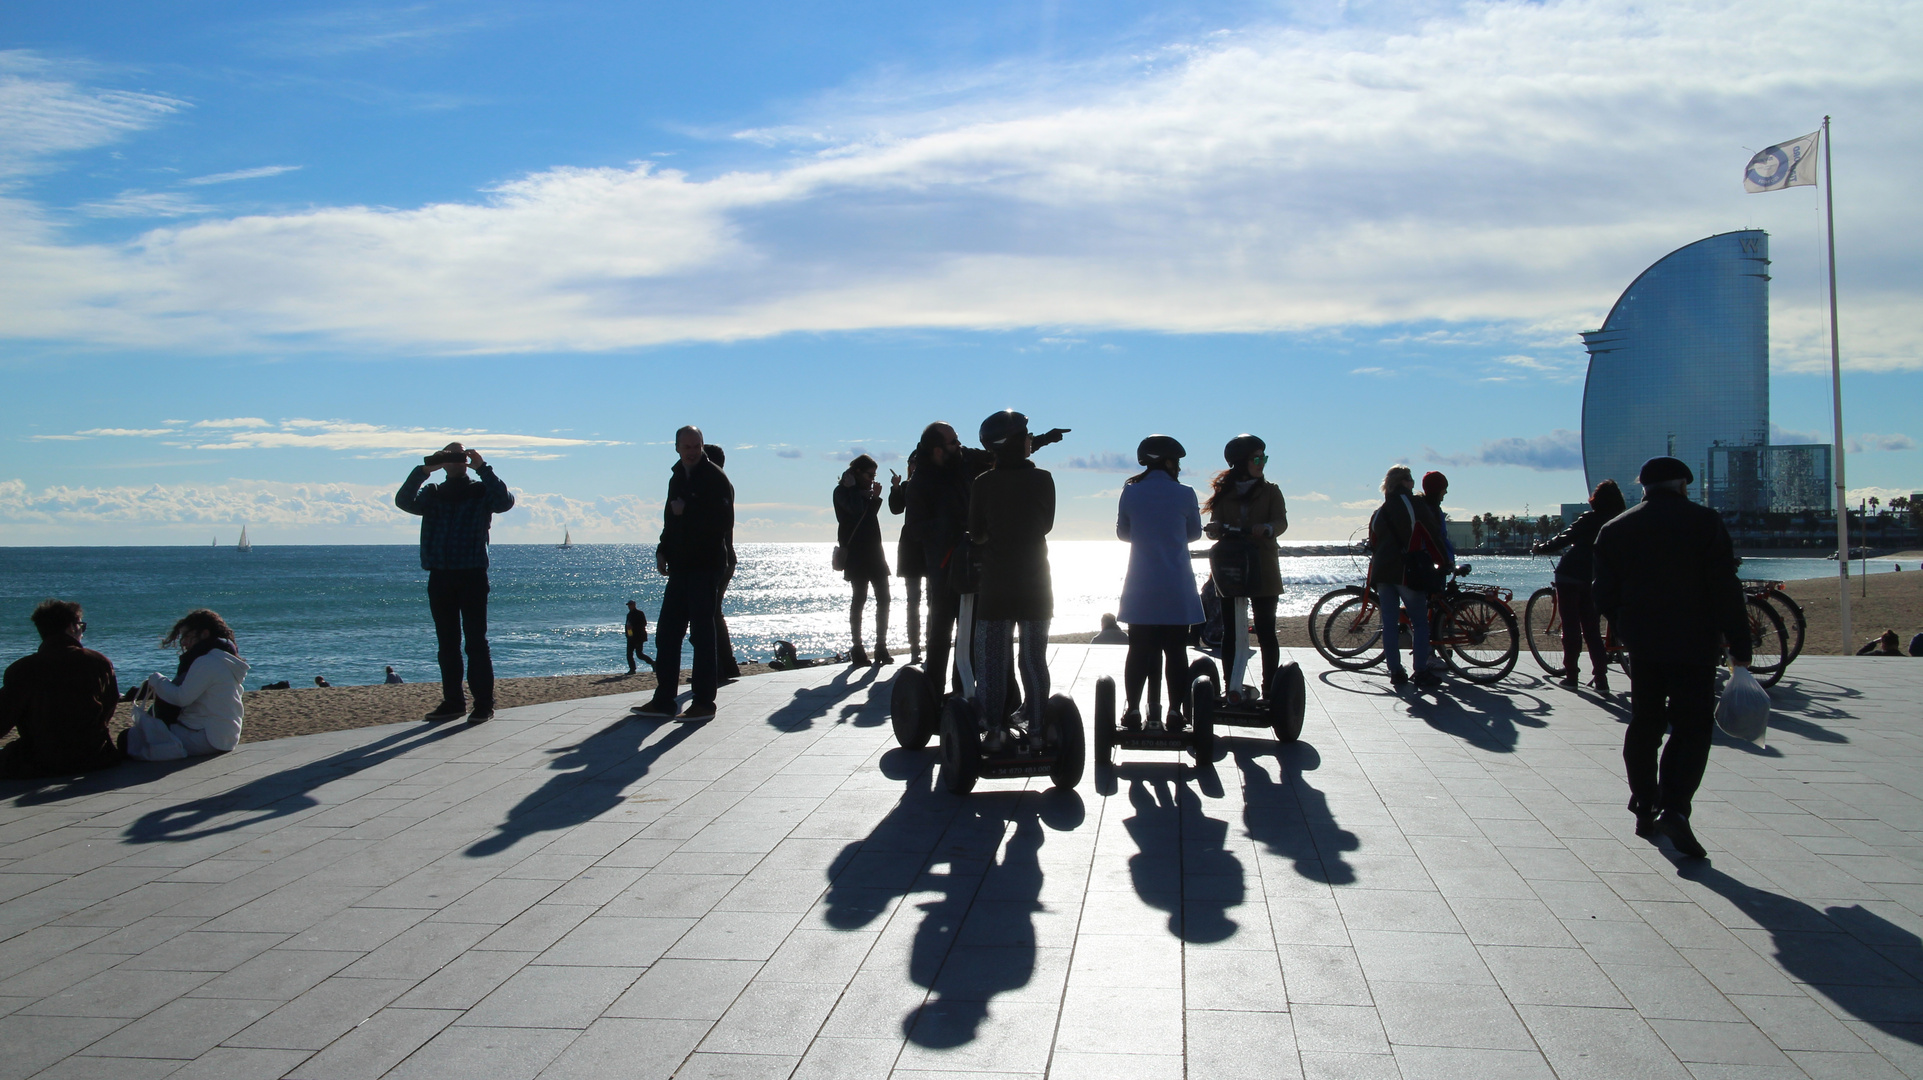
[467,717,706,857]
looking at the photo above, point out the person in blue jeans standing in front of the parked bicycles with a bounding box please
[1369,465,1448,686]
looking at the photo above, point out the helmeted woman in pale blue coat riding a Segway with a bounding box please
[1115,434,1199,730]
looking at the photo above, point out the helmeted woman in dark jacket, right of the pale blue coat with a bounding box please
[1202,434,1288,705]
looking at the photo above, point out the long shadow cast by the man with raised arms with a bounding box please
[125,724,467,844]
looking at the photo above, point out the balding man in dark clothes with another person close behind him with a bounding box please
[635,425,735,721]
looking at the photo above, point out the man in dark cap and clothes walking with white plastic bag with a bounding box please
[1596,457,1750,859]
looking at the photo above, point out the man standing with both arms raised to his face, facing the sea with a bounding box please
[394,442,513,724]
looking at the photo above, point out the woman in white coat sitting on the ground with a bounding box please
[127,607,248,761]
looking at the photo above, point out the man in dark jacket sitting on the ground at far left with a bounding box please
[0,600,121,778]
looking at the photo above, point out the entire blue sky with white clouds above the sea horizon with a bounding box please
[0,0,1923,544]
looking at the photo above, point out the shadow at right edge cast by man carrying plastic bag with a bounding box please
[1677,861,1923,1045]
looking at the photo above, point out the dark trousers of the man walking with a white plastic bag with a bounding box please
[1623,655,1715,817]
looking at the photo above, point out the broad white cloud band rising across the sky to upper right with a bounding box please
[0,0,1923,371]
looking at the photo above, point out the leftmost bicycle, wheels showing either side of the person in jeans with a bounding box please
[1310,563,1521,684]
